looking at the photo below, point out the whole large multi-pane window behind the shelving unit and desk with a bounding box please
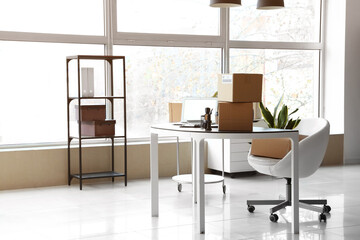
[0,0,323,144]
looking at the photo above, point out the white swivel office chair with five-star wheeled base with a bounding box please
[247,118,331,222]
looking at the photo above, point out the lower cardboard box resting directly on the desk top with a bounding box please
[218,102,253,132]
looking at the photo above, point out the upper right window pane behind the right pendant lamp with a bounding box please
[230,0,321,42]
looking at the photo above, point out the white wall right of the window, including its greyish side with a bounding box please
[323,0,360,164]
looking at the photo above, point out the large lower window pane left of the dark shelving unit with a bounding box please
[0,41,104,144]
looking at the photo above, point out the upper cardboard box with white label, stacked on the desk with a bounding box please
[218,73,263,102]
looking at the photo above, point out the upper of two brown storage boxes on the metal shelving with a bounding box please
[75,105,106,121]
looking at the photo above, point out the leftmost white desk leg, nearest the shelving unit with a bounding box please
[150,133,159,217]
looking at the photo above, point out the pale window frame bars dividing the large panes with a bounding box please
[0,0,326,149]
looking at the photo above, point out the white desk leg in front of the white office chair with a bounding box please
[291,136,299,234]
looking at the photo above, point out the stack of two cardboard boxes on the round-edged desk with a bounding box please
[218,73,263,132]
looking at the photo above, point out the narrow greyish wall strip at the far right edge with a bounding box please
[344,0,360,163]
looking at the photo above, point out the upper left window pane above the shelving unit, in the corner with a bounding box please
[0,0,104,36]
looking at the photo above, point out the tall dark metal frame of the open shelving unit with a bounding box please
[66,55,127,190]
